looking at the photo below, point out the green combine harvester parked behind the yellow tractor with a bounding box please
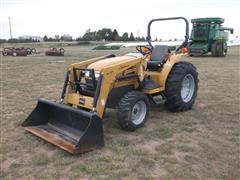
[188,17,233,57]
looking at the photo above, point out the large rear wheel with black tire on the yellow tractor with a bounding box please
[165,61,198,112]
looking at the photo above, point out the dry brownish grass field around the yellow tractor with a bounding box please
[0,46,240,180]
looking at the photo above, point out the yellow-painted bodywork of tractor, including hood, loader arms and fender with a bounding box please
[64,54,181,117]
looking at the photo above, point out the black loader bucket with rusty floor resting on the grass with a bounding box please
[22,99,104,154]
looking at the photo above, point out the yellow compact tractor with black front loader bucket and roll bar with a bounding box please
[22,17,198,153]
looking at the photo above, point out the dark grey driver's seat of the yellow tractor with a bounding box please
[147,45,169,71]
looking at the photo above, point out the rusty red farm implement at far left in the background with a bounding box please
[2,47,36,56]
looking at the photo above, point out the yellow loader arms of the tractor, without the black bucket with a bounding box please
[64,56,145,118]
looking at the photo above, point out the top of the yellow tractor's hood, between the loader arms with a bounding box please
[88,53,143,71]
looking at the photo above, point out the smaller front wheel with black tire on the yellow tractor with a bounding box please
[117,91,150,131]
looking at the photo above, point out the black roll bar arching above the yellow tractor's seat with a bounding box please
[147,17,189,52]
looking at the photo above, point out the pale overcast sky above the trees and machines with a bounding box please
[0,0,240,39]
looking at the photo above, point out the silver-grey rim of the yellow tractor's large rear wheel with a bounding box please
[181,74,195,103]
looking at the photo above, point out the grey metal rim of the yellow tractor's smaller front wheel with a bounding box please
[132,100,147,125]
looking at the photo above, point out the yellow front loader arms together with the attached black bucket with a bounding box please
[22,56,144,153]
